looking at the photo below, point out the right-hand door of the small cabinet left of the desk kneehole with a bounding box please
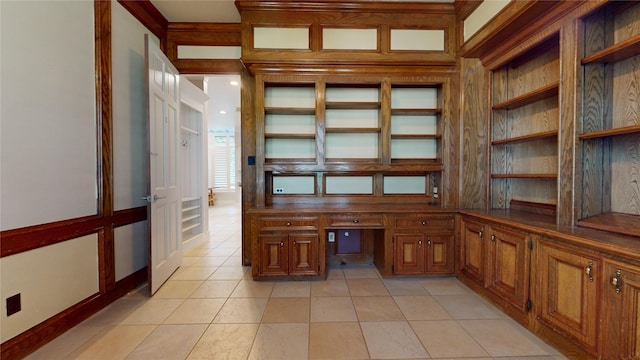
[289,234,318,275]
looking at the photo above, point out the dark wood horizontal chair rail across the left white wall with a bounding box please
[0,206,147,257]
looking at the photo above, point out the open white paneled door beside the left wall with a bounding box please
[145,35,182,295]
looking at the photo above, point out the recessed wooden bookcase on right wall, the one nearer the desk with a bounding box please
[490,36,560,215]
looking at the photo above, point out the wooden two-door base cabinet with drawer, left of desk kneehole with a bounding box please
[253,216,320,277]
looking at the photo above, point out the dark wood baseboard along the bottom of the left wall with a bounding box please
[0,267,147,360]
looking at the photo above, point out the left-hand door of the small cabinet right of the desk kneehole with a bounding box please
[394,234,425,275]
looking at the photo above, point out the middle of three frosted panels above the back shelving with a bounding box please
[322,29,378,50]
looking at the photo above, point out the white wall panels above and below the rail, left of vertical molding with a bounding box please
[0,0,99,342]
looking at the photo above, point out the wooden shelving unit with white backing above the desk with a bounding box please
[256,75,444,205]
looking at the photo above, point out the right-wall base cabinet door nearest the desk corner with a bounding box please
[460,219,486,286]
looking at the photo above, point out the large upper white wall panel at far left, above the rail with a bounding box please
[0,0,97,230]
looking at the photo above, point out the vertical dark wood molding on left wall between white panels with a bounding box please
[94,0,116,293]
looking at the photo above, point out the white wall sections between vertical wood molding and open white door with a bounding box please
[111,0,159,281]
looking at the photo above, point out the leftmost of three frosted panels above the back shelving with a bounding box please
[253,27,309,49]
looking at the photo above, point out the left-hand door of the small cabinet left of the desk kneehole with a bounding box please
[258,234,289,275]
